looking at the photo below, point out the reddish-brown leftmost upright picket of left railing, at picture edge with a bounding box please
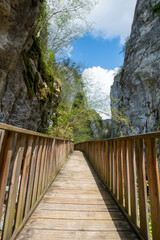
[0,131,15,223]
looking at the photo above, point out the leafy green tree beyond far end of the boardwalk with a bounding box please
[49,62,102,142]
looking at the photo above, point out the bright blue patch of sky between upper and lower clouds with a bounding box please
[71,34,124,70]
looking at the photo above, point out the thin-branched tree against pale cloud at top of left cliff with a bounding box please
[37,0,97,54]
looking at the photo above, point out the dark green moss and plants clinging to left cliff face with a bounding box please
[23,35,61,103]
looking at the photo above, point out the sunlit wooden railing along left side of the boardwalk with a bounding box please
[0,123,74,240]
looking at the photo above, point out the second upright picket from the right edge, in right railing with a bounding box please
[135,139,149,240]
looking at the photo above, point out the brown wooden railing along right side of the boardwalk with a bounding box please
[75,132,160,240]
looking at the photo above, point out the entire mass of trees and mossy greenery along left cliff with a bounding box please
[23,0,125,140]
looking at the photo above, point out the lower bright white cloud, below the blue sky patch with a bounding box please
[82,66,119,119]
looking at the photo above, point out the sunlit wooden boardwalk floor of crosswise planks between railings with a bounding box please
[17,151,139,240]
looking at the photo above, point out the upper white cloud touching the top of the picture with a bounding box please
[88,0,136,43]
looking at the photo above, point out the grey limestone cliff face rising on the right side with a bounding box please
[111,0,160,135]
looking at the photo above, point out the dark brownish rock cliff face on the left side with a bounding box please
[0,0,60,130]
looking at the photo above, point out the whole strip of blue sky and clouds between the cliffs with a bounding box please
[62,0,137,118]
